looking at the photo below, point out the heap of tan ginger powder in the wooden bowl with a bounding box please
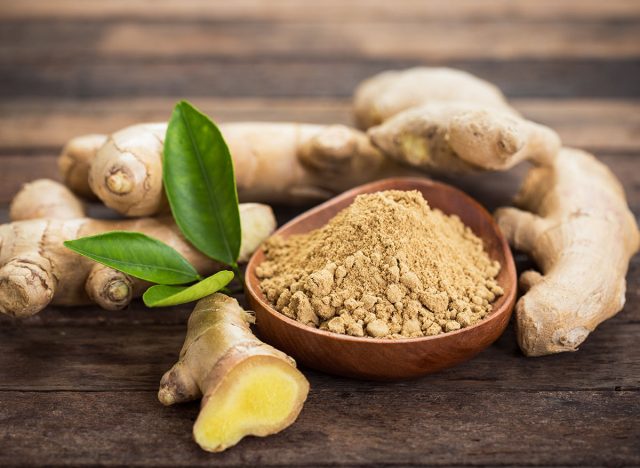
[256,190,503,338]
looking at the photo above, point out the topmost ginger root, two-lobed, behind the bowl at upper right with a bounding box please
[355,68,560,173]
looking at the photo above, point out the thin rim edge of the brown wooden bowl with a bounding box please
[244,177,518,345]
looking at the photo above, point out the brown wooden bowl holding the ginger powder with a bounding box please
[246,178,517,380]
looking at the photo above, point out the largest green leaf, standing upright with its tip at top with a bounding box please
[163,101,241,265]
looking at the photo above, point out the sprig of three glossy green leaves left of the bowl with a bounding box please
[65,101,241,307]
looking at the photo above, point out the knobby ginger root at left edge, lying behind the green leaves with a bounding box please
[0,181,276,317]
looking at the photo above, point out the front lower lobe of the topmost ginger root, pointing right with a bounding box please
[369,104,560,174]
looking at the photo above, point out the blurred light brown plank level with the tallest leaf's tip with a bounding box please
[0,97,640,153]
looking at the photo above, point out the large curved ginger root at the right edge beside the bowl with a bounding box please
[496,148,640,356]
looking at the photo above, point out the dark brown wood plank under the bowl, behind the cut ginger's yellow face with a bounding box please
[0,312,640,394]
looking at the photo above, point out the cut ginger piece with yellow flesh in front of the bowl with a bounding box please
[158,294,309,452]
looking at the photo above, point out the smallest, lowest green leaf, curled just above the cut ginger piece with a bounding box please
[142,270,233,307]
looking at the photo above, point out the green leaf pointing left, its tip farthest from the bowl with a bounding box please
[64,231,200,284]
